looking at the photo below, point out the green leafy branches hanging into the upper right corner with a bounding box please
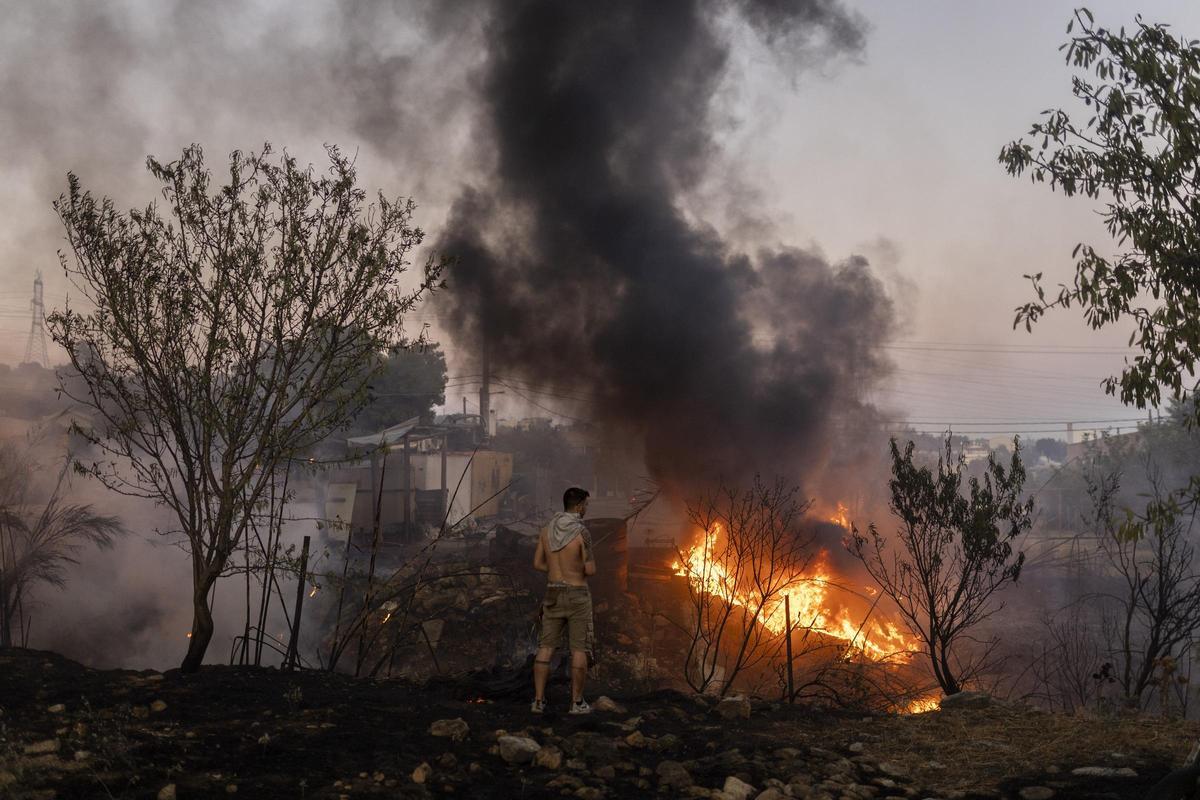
[1000,8,1200,412]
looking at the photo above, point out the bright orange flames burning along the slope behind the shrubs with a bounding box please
[671,520,917,662]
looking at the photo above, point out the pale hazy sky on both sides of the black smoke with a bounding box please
[0,0,1200,435]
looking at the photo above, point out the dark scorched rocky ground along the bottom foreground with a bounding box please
[0,650,1198,800]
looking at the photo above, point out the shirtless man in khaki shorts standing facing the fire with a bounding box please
[529,487,596,714]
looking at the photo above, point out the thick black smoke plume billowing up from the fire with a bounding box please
[439,0,894,489]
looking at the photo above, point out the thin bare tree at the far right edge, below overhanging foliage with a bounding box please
[1085,455,1200,708]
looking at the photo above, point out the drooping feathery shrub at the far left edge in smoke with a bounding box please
[0,443,124,648]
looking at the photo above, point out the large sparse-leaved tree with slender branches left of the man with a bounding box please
[48,145,451,672]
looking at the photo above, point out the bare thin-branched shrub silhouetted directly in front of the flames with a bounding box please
[678,479,812,694]
